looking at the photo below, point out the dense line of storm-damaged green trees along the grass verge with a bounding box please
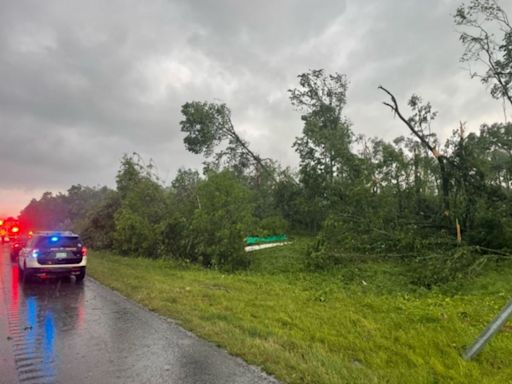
[20,0,512,285]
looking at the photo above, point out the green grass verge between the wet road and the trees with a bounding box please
[88,239,512,384]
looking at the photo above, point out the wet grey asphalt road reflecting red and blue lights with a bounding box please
[0,245,277,384]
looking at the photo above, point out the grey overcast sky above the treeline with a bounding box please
[0,0,512,216]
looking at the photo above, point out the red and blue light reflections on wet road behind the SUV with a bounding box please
[0,254,84,383]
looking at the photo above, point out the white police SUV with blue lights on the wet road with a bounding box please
[18,231,87,282]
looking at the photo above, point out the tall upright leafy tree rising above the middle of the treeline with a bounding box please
[289,69,358,230]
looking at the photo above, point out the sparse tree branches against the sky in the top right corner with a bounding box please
[454,0,512,106]
